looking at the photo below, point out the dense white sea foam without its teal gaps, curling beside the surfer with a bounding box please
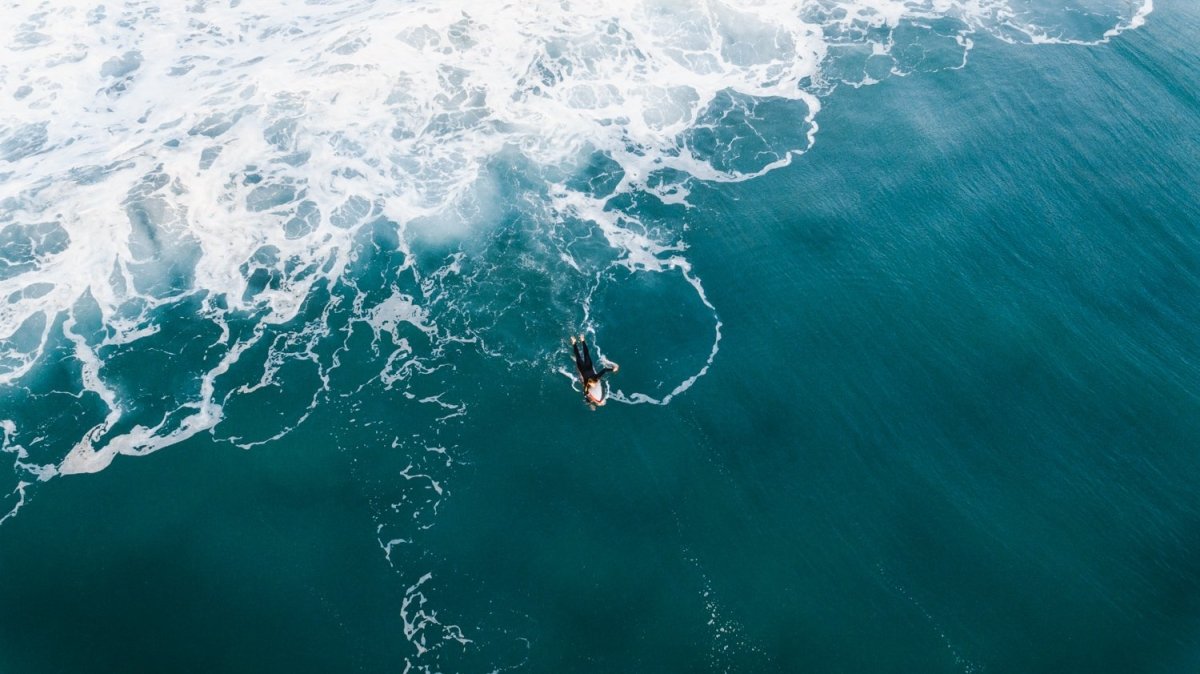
[0,0,1153,486]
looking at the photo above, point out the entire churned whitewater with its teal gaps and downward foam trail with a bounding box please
[0,0,1153,662]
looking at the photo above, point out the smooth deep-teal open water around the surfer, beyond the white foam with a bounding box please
[0,2,1200,673]
